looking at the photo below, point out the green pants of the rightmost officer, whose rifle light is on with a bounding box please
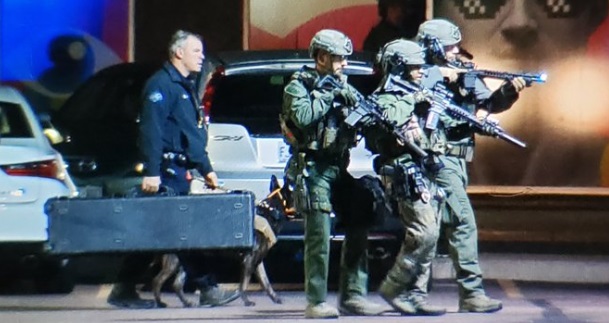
[410,156,484,298]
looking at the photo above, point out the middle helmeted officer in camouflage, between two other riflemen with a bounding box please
[365,39,446,315]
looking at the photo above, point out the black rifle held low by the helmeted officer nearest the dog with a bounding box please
[317,75,427,158]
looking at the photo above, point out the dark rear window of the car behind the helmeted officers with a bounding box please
[210,71,378,136]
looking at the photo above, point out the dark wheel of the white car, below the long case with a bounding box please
[34,259,75,294]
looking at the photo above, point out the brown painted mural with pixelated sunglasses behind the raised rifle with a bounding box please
[433,0,609,187]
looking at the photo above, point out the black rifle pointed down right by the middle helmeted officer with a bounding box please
[388,76,527,148]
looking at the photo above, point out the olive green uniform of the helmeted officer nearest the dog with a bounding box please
[282,68,368,304]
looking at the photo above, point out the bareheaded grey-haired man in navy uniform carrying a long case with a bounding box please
[108,30,239,308]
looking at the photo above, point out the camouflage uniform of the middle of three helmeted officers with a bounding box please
[366,92,445,297]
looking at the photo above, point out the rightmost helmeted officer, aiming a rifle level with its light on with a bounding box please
[409,19,527,312]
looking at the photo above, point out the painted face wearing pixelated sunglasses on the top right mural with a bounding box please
[434,0,606,67]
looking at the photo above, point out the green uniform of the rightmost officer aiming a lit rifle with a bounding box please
[411,67,518,299]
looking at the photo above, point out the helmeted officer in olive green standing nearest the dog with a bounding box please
[280,29,383,318]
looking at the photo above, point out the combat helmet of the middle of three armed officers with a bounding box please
[377,39,425,73]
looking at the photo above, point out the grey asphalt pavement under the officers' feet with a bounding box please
[0,280,609,323]
